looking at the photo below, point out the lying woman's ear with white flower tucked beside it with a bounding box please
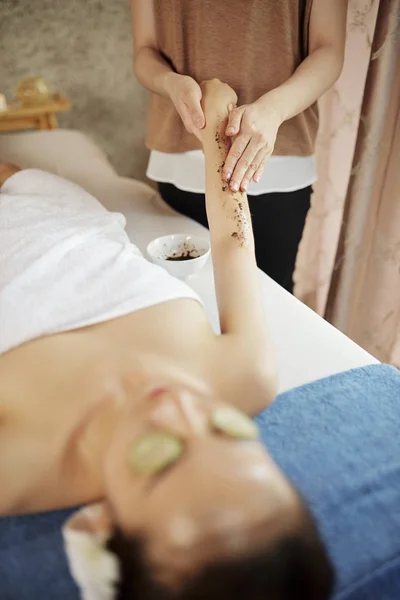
[62,503,120,600]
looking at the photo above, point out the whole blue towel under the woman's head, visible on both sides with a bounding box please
[0,365,400,600]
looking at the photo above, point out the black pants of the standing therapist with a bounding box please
[158,183,311,293]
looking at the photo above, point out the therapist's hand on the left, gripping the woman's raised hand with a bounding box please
[165,73,206,140]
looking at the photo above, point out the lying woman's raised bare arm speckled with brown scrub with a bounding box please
[201,79,276,396]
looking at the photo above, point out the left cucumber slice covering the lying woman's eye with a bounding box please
[129,431,184,475]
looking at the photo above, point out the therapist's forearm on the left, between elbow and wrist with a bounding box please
[134,46,178,97]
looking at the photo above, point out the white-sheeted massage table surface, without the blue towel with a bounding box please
[0,130,378,392]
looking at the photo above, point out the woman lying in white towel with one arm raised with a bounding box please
[0,80,333,600]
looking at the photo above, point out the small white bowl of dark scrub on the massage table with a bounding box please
[147,233,210,279]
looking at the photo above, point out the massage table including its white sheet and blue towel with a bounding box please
[0,130,400,600]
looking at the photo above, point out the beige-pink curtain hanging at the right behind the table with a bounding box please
[295,0,400,366]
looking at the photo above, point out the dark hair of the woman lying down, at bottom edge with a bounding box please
[108,505,334,600]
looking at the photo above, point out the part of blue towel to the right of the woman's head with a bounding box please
[257,365,400,600]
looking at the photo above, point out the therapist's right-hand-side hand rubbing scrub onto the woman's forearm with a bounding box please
[223,92,282,191]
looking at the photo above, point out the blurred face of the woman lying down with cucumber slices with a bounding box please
[105,381,297,584]
